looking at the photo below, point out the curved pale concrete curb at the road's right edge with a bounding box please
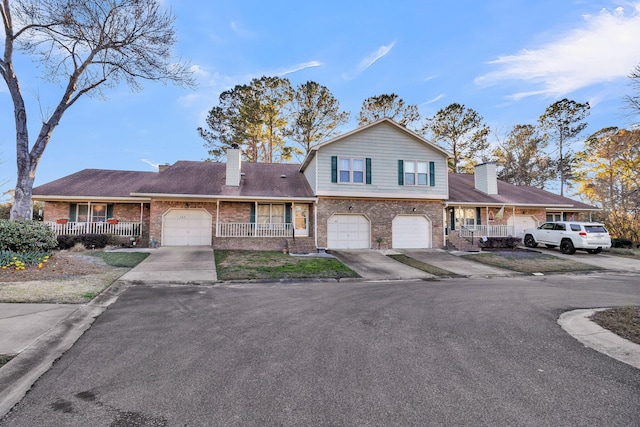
[558,308,640,369]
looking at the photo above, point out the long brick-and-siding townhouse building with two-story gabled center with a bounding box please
[33,119,597,252]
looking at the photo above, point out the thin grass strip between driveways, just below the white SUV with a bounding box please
[462,251,602,273]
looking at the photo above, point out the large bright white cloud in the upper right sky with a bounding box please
[475,2,640,100]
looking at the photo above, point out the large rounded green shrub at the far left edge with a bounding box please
[0,219,58,252]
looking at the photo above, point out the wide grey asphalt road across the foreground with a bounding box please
[0,274,640,427]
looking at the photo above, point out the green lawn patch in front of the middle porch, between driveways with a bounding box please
[215,250,358,280]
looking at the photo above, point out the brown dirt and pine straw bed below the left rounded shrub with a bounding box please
[0,251,114,283]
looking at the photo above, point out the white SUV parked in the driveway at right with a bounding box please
[522,221,611,255]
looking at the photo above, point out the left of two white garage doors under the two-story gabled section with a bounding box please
[327,214,371,249]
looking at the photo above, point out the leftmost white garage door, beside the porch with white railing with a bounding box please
[162,209,213,246]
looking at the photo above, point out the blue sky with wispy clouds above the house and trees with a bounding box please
[0,0,640,200]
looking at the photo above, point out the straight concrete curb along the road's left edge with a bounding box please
[0,280,127,420]
